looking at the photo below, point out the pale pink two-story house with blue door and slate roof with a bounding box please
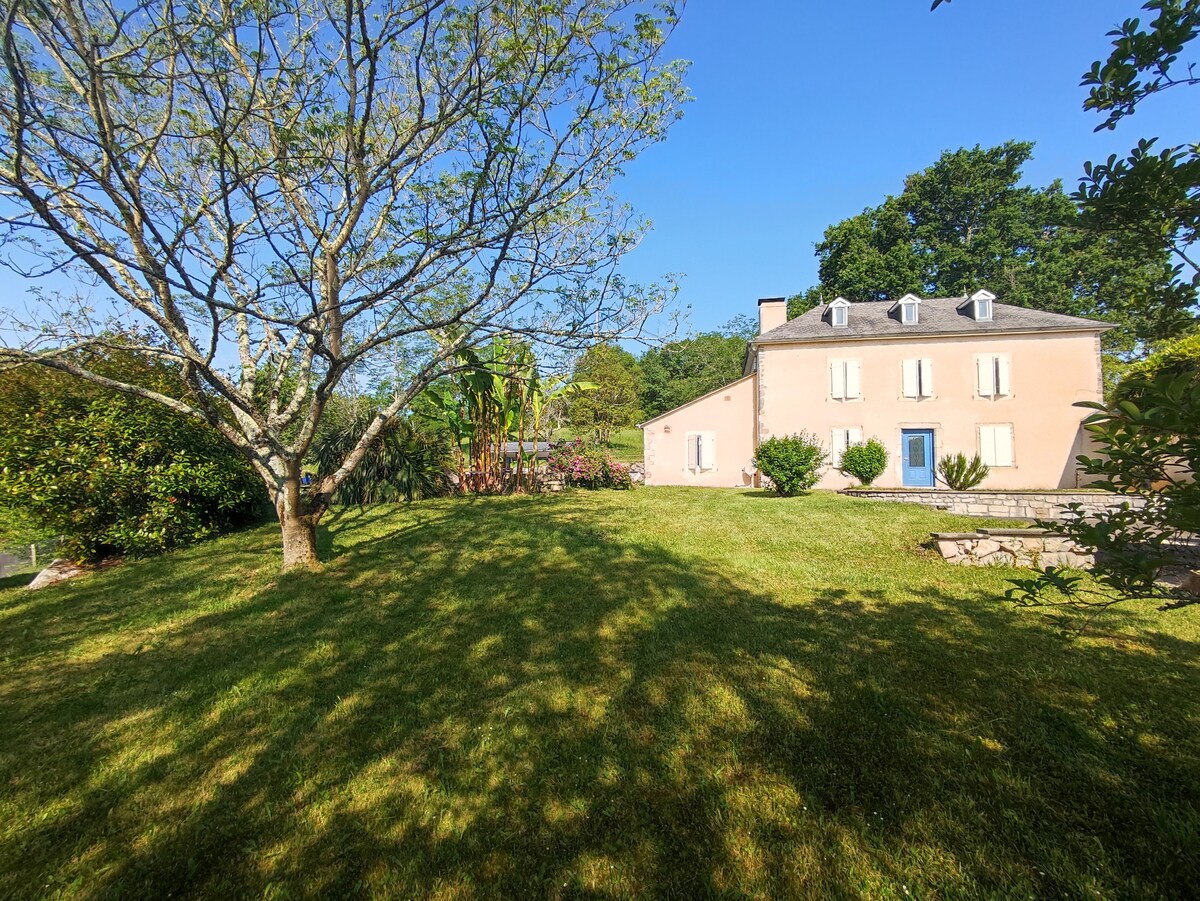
[642,290,1108,488]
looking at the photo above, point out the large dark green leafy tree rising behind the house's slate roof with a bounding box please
[811,142,1196,355]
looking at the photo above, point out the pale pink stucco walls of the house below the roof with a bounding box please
[644,299,1102,489]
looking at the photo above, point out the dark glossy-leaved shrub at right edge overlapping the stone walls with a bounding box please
[1008,372,1200,607]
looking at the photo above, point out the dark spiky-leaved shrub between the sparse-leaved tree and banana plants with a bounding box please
[310,403,451,505]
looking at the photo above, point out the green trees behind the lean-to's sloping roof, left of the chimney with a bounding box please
[638,333,748,419]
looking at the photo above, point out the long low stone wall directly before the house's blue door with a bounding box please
[840,488,1144,521]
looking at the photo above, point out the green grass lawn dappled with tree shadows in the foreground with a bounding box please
[0,488,1200,899]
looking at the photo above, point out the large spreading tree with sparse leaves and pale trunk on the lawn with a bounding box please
[0,0,685,569]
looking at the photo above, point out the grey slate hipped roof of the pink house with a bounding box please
[752,298,1112,344]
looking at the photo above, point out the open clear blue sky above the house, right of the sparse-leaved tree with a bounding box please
[622,0,1200,331]
